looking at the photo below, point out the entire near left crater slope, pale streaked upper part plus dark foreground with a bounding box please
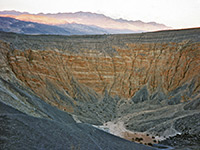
[0,40,155,150]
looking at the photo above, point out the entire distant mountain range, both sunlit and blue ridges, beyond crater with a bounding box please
[0,11,170,35]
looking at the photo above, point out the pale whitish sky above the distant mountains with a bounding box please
[0,0,200,28]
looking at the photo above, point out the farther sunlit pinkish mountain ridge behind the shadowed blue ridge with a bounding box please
[0,11,170,34]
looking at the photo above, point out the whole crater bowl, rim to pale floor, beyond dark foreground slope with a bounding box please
[0,29,200,149]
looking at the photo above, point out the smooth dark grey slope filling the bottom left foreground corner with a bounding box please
[0,103,154,150]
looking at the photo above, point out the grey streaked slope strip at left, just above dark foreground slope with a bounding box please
[0,78,75,123]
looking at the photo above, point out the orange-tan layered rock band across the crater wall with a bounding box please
[4,41,200,111]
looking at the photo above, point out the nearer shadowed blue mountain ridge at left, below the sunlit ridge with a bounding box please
[0,17,111,35]
